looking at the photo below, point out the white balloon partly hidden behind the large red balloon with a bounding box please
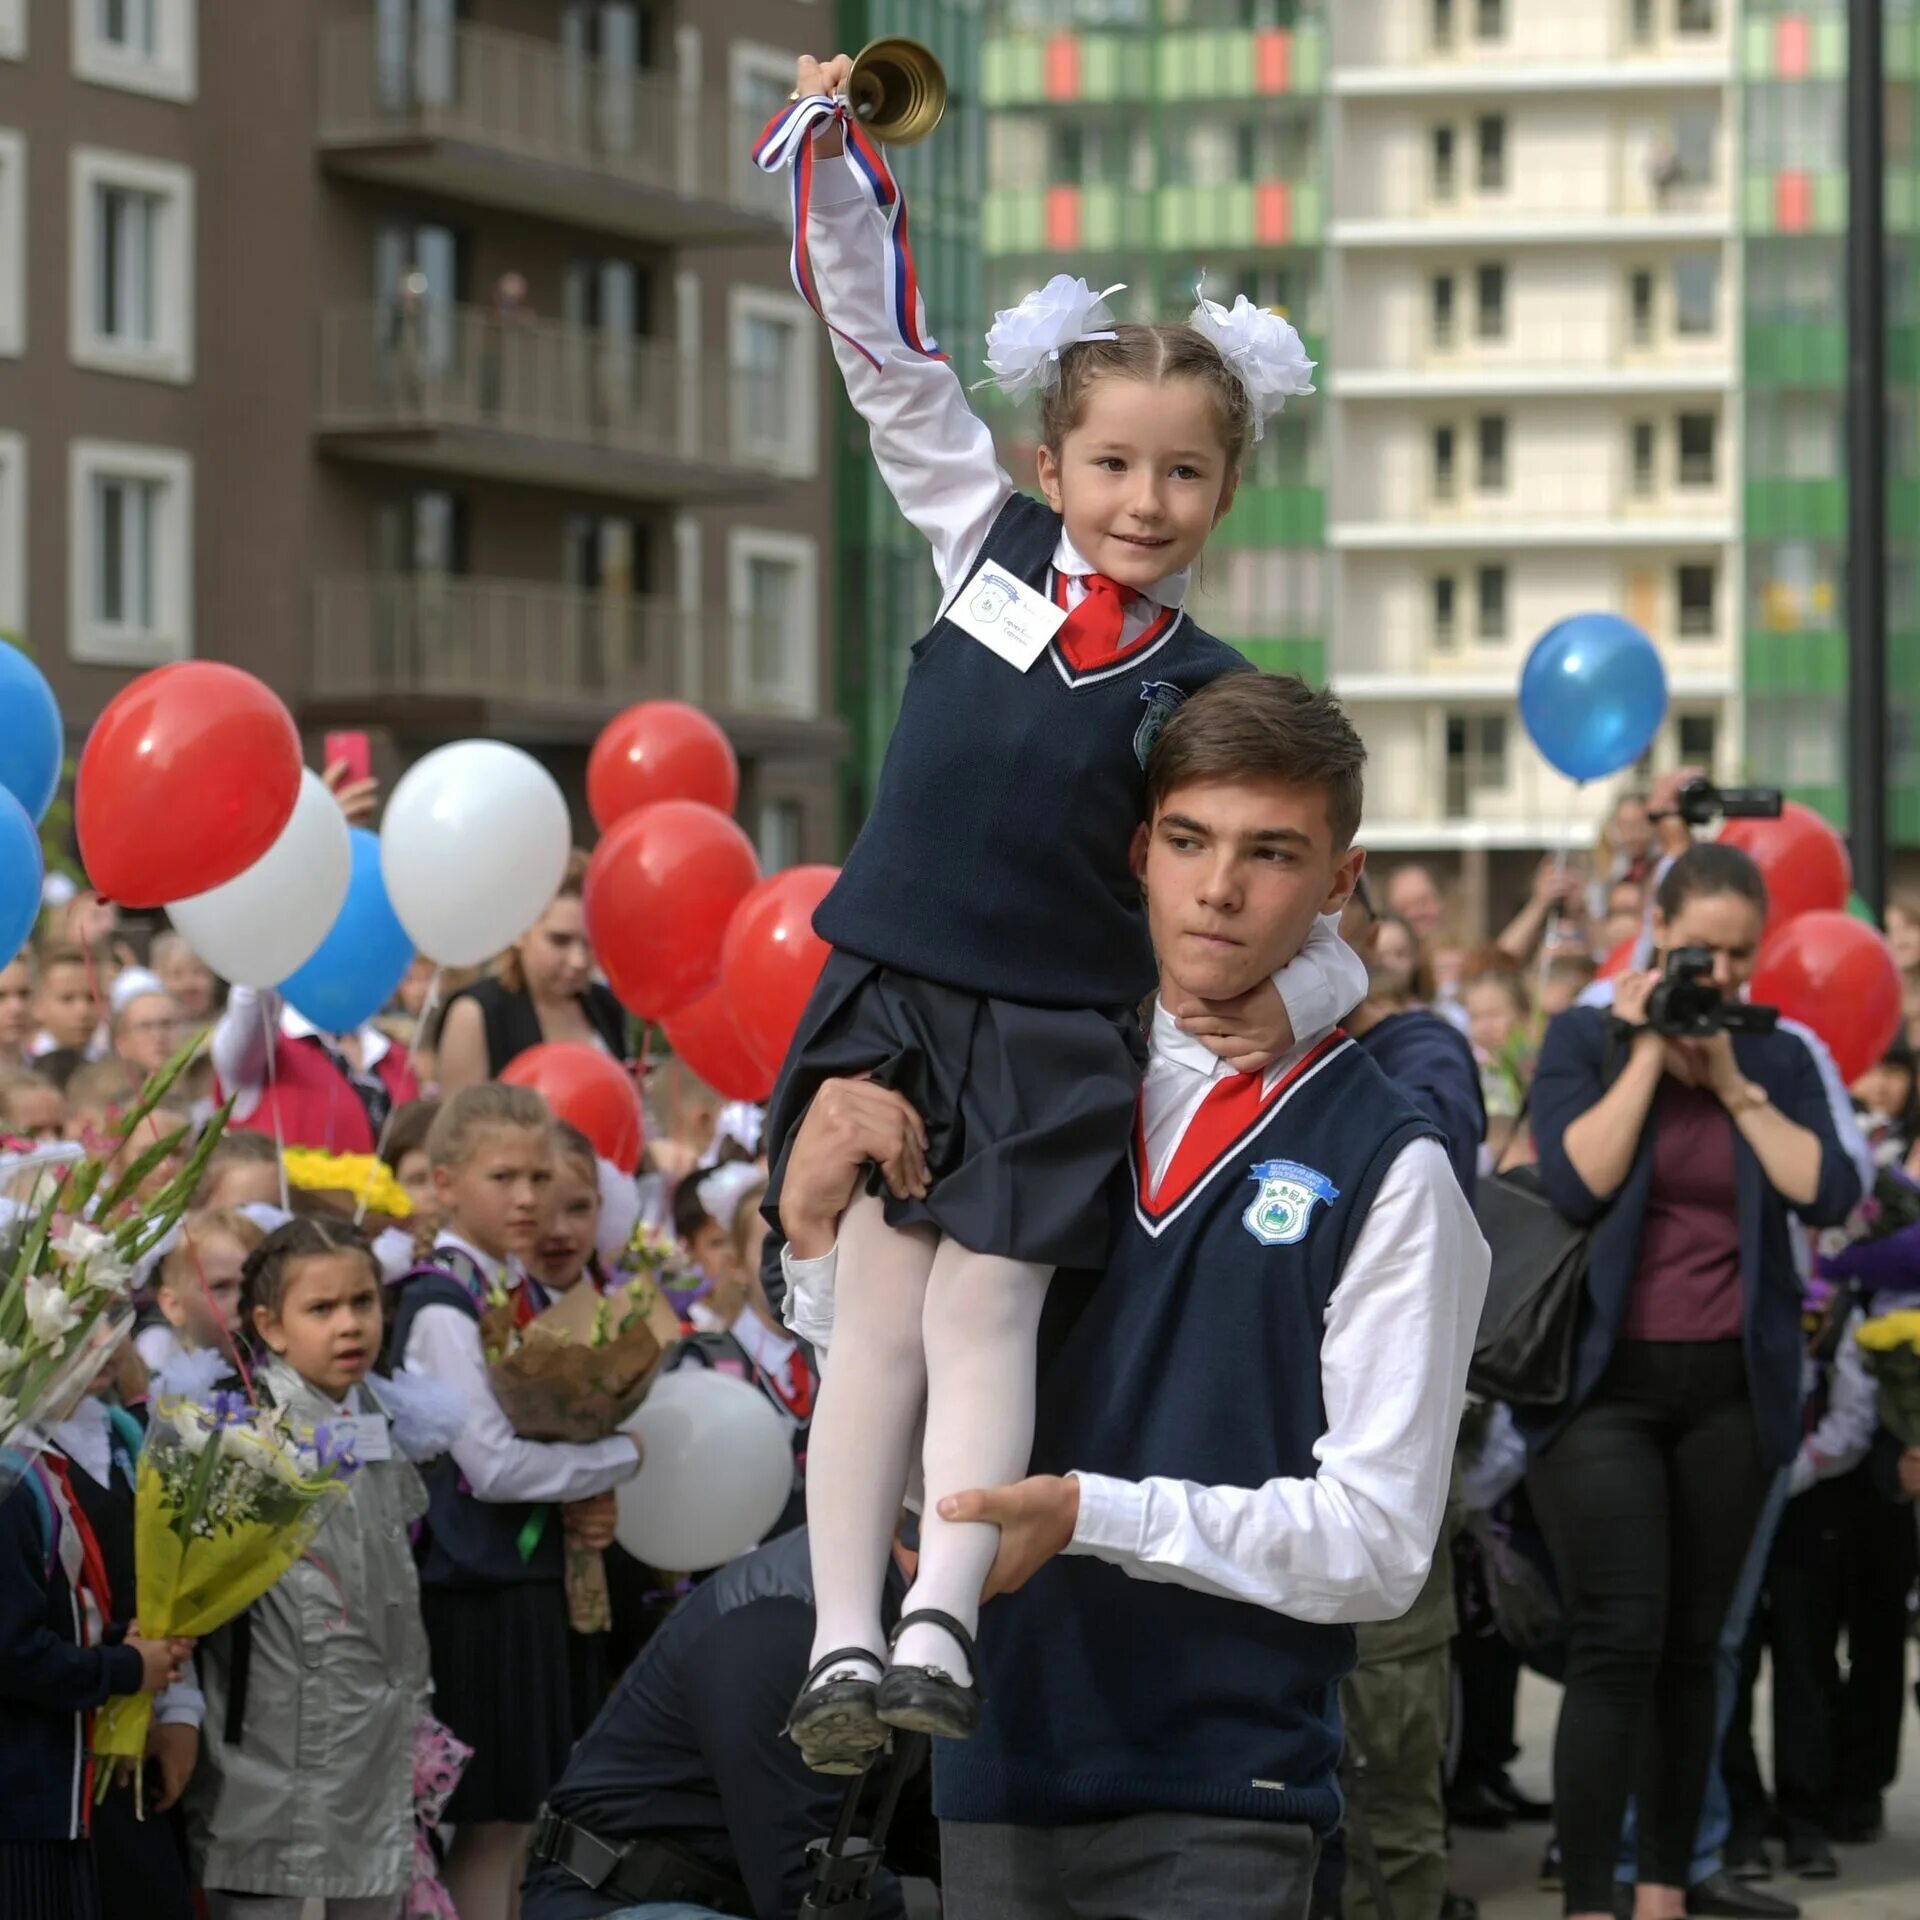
[167,770,353,987]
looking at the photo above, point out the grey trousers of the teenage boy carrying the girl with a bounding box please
[941,1812,1319,1920]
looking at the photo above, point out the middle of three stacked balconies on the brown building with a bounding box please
[317,301,806,501]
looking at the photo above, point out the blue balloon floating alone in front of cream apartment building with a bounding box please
[1521,612,1667,780]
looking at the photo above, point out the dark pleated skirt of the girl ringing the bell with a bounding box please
[766,950,1146,1267]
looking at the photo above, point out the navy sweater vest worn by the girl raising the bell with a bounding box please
[814,493,1248,1006]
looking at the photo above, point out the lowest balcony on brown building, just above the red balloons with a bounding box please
[303,574,837,753]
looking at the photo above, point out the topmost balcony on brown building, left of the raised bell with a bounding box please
[319,19,785,246]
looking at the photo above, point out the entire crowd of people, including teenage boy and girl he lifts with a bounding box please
[0,41,1920,1920]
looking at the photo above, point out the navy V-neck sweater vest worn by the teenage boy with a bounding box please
[935,1033,1436,1834]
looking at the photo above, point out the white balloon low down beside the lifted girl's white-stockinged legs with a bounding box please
[614,1367,793,1572]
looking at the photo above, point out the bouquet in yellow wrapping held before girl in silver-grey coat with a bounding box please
[94,1394,357,1791]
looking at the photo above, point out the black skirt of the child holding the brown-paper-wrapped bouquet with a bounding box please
[420,1580,574,1826]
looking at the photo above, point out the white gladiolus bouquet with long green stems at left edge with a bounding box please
[0,1046,227,1494]
